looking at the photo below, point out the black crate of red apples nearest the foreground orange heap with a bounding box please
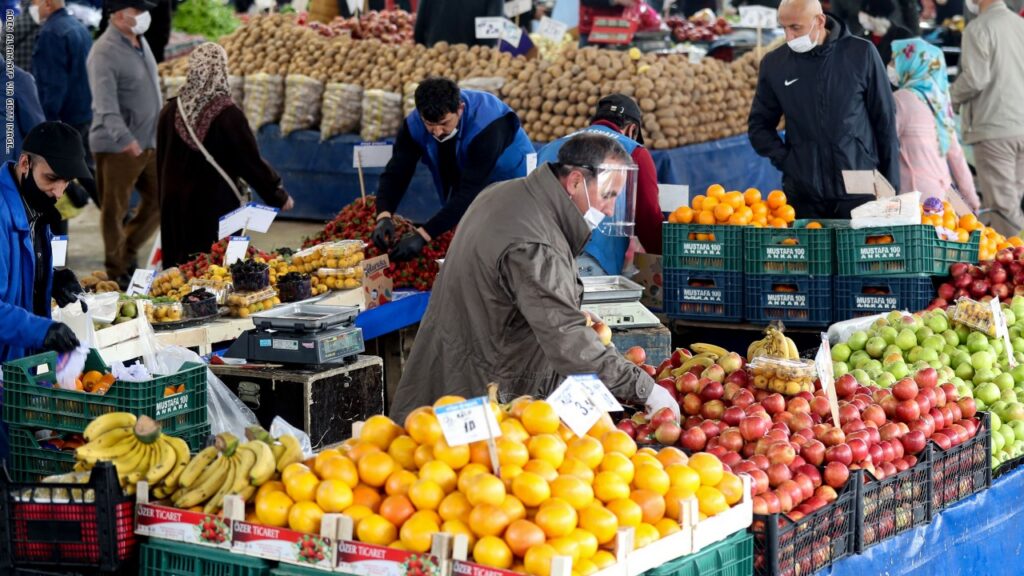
[751,478,860,576]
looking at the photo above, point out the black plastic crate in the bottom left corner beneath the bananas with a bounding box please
[0,462,136,573]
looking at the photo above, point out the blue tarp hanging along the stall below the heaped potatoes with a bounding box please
[257,124,781,221]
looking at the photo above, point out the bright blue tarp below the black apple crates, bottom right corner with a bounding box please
[816,461,1024,576]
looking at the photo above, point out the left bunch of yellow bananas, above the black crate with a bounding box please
[75,412,188,494]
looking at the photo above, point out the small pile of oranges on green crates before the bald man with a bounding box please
[669,184,797,228]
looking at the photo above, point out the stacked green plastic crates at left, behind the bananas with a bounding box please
[3,349,210,482]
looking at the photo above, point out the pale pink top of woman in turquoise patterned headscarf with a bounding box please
[893,90,978,205]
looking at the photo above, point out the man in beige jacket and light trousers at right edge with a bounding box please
[949,0,1024,236]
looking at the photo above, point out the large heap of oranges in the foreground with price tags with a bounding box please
[250,397,742,576]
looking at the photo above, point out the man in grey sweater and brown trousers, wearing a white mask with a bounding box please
[86,0,163,286]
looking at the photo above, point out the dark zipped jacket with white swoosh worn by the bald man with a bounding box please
[748,16,900,217]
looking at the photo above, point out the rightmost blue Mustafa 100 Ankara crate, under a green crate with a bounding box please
[833,276,935,320]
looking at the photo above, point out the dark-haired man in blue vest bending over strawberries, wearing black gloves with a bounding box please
[373,78,534,260]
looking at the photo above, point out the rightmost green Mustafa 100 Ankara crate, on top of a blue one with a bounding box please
[836,224,981,276]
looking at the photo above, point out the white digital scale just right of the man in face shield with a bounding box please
[581,276,662,329]
